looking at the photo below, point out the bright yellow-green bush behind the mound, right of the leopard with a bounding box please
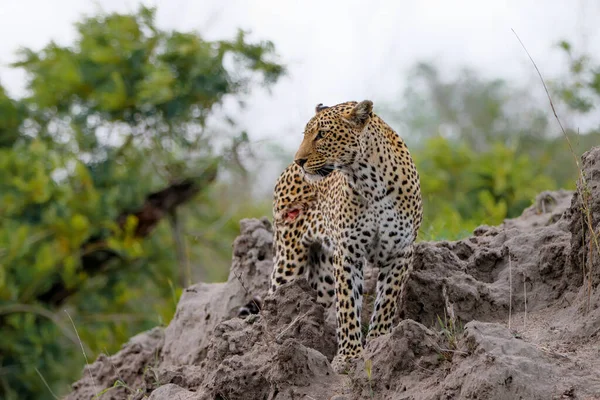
[414,136,555,239]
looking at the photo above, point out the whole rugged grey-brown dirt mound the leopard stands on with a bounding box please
[68,148,600,400]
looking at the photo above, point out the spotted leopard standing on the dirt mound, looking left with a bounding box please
[239,100,423,373]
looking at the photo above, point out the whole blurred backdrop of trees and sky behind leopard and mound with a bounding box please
[0,0,600,399]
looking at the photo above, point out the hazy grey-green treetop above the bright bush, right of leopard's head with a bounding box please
[388,63,548,151]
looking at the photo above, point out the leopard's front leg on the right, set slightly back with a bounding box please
[367,244,413,340]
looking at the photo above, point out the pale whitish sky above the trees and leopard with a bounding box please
[0,0,600,154]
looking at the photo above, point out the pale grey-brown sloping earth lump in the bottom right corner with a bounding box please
[442,321,600,400]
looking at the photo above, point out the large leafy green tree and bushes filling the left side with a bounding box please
[0,7,284,399]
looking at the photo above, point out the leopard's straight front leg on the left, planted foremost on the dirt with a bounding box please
[331,246,363,373]
